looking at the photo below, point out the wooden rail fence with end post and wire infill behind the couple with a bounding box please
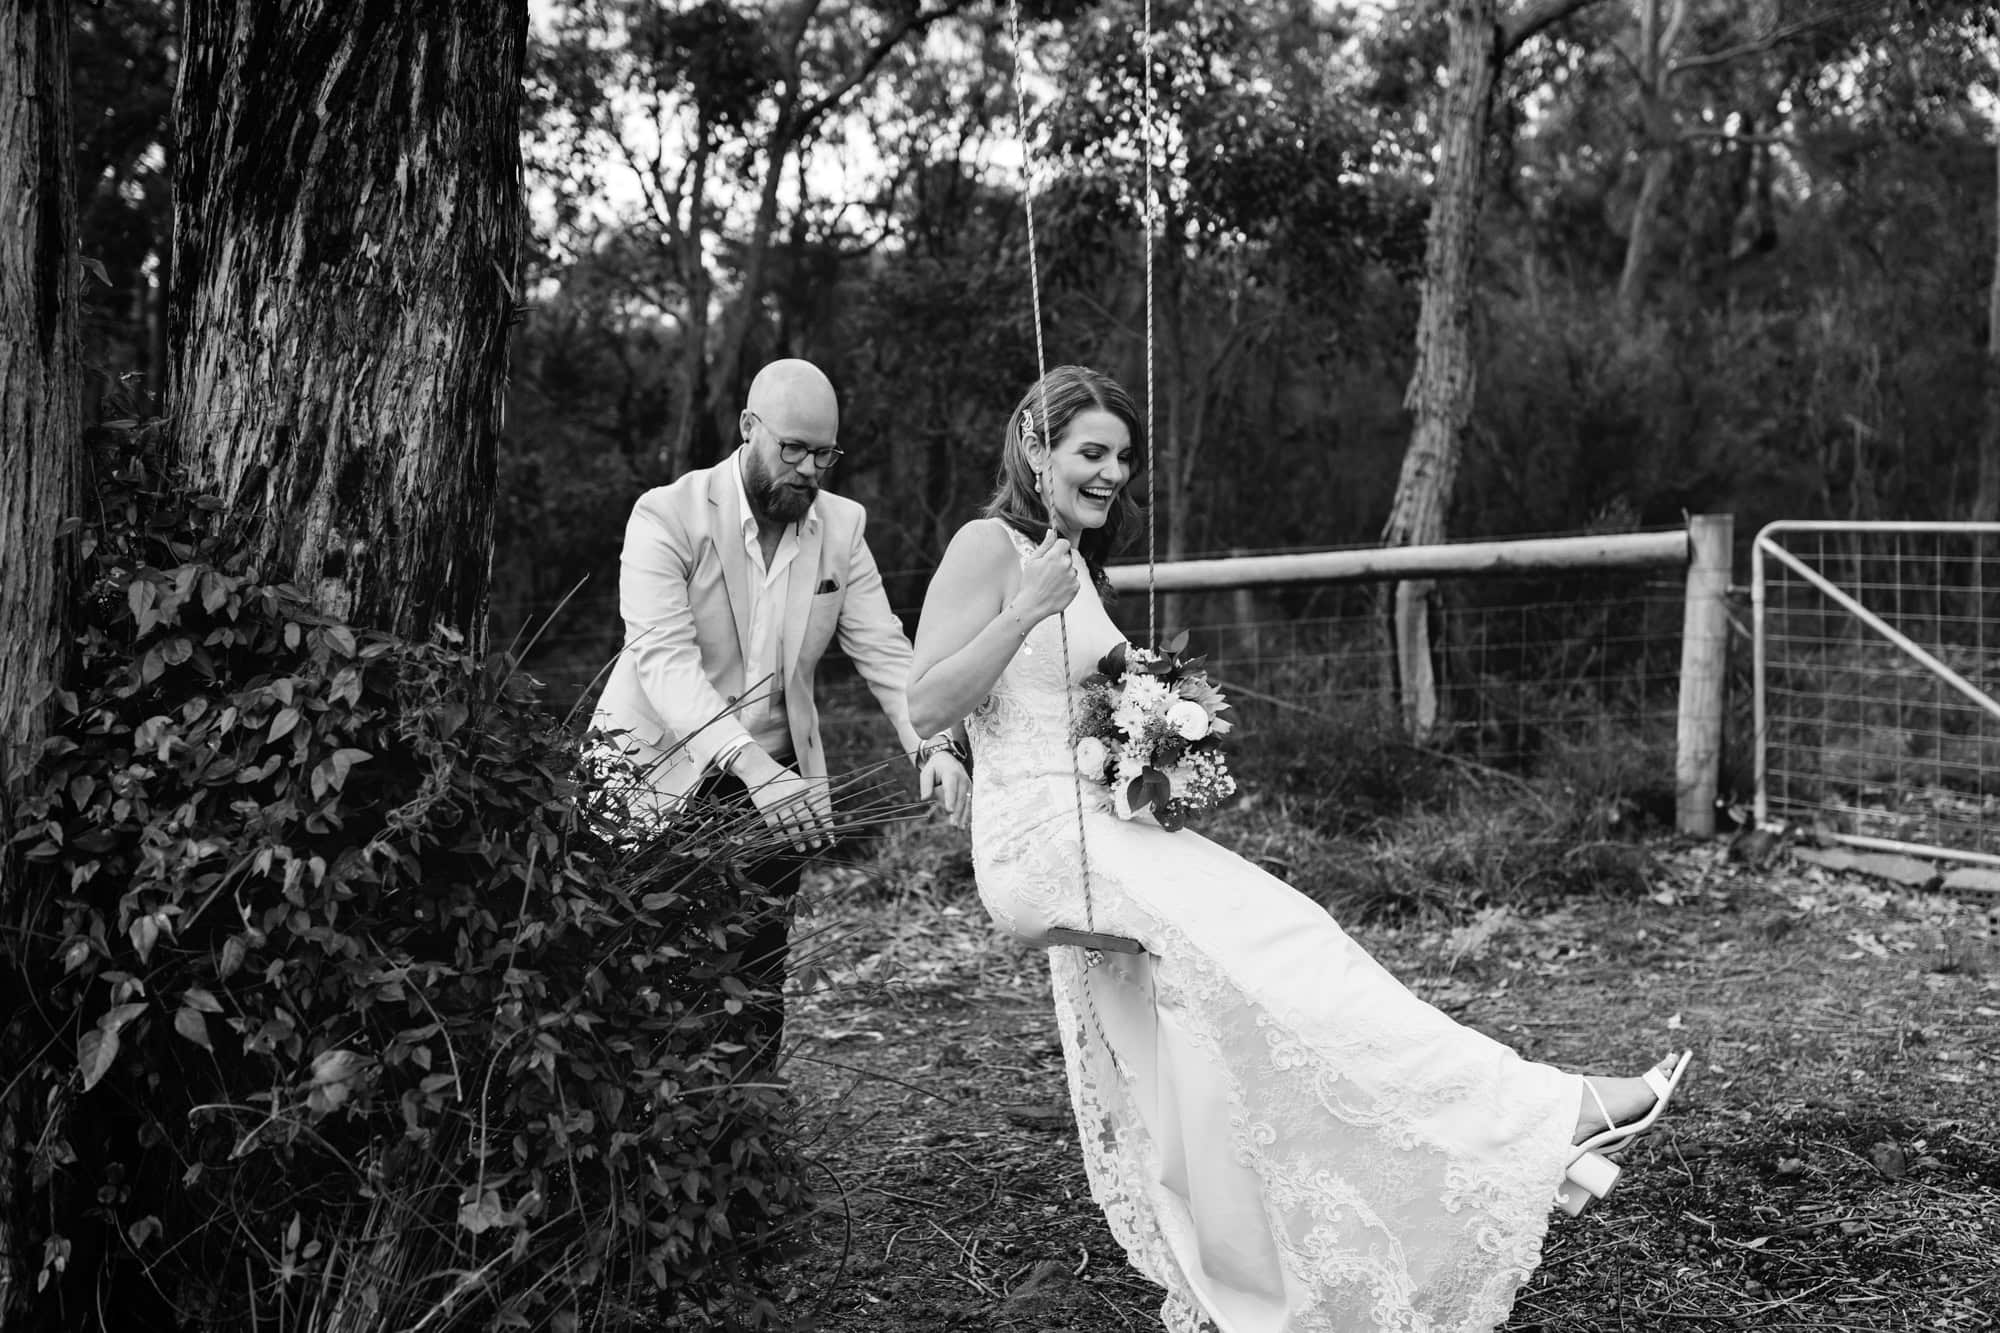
[496,516,1730,833]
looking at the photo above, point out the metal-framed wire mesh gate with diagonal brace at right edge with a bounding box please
[1750,522,2000,865]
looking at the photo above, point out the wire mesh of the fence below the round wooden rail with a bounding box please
[508,570,1686,783]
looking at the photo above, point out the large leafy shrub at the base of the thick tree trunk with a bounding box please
[0,430,812,1329]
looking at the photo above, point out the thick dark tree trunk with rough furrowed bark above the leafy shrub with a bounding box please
[170,0,528,644]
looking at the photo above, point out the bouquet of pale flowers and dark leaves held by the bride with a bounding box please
[1072,632,1236,829]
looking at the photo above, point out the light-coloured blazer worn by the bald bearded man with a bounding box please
[590,454,918,819]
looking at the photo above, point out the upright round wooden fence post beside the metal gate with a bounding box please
[1674,514,1736,837]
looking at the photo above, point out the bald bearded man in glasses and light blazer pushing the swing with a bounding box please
[592,360,968,1071]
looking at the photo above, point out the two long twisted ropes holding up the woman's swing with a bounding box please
[1008,0,1160,960]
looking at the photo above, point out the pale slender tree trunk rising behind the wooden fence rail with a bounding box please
[1382,0,1500,741]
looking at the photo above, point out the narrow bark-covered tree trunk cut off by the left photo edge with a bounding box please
[0,0,80,768]
